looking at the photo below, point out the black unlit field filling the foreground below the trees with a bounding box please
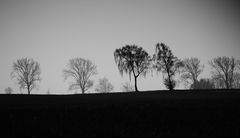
[0,90,240,138]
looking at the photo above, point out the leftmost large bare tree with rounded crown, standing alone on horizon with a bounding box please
[11,58,41,94]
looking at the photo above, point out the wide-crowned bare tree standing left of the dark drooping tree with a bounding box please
[63,58,97,94]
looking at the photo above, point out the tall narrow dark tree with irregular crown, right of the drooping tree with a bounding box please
[153,43,183,90]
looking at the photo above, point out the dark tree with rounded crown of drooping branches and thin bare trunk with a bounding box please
[114,45,151,92]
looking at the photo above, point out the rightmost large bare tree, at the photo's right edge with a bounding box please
[209,56,239,89]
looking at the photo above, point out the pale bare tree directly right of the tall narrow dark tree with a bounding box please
[181,58,204,89]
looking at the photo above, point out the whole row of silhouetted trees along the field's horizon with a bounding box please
[5,43,240,94]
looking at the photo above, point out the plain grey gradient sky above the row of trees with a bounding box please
[0,0,240,94]
